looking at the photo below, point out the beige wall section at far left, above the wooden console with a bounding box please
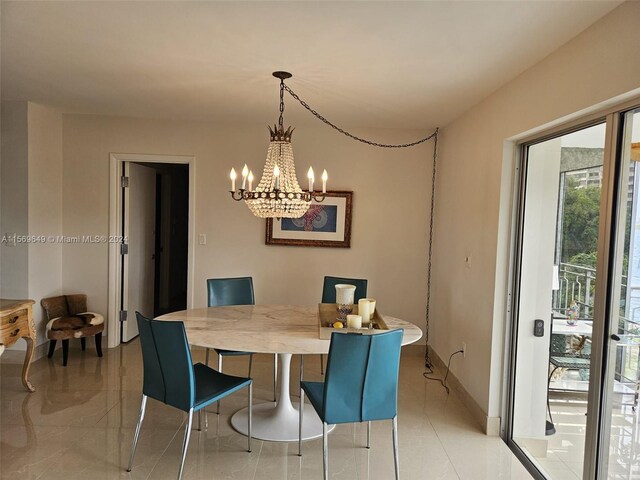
[0,102,62,350]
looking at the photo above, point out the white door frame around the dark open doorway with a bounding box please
[107,153,196,348]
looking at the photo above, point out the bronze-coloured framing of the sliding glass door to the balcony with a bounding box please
[502,98,640,479]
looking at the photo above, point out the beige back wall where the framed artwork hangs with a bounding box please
[63,116,432,340]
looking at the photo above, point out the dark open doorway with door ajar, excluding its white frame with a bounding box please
[120,162,189,342]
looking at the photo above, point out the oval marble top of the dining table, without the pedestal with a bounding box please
[158,305,422,354]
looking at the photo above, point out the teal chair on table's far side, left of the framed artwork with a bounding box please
[205,277,278,413]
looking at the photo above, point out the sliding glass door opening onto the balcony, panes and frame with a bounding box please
[506,103,640,480]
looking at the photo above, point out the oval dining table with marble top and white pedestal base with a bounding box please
[157,304,422,442]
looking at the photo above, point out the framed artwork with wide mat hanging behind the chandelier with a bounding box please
[266,190,353,248]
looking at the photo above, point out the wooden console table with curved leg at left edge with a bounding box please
[0,299,36,392]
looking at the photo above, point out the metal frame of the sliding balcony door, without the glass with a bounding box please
[501,92,640,479]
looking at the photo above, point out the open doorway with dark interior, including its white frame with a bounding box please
[107,154,195,348]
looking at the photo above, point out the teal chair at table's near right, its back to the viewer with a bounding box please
[298,329,404,480]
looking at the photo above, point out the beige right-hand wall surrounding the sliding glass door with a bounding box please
[430,2,640,428]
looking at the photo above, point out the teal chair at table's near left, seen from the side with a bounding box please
[127,312,252,480]
